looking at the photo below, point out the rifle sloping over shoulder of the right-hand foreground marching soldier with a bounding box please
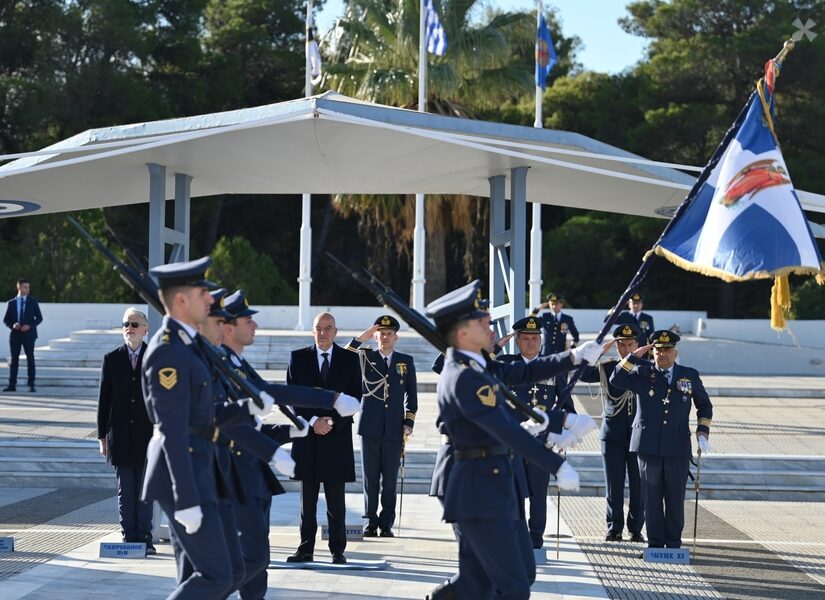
[326,252,544,423]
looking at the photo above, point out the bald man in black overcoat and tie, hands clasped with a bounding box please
[286,313,361,564]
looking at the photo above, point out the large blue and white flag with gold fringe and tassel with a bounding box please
[652,48,825,329]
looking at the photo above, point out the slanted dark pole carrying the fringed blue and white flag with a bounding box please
[562,40,794,393]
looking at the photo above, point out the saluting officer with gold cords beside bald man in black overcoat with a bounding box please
[346,315,418,537]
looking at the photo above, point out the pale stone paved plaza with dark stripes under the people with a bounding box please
[0,356,825,600]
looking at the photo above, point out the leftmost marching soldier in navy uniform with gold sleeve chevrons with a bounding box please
[143,257,232,600]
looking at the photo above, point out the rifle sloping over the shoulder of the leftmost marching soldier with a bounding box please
[66,216,303,429]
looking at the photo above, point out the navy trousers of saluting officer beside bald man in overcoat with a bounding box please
[361,436,401,529]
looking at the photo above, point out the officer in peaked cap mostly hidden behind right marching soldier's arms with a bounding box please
[497,316,576,549]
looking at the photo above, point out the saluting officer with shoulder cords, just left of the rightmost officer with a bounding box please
[581,323,645,543]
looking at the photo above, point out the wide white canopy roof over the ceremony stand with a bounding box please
[0,92,825,224]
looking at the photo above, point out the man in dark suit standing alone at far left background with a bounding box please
[3,279,43,392]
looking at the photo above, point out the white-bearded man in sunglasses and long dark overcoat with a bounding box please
[97,307,156,554]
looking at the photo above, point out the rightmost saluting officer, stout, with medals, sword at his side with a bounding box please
[610,329,713,548]
